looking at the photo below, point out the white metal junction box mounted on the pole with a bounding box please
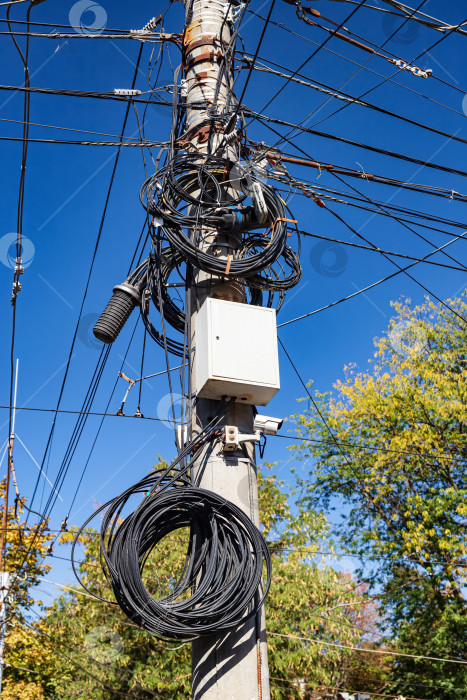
[195,298,280,406]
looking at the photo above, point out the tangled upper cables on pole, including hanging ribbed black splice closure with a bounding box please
[94,153,302,350]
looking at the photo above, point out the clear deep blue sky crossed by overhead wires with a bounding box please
[0,0,467,596]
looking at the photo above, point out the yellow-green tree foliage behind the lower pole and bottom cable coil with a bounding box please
[5,468,374,700]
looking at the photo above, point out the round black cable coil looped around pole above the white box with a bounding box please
[140,154,287,279]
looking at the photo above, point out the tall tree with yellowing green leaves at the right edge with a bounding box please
[293,298,467,700]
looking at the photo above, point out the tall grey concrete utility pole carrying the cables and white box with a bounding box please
[184,0,270,700]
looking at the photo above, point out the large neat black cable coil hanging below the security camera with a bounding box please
[72,418,271,641]
